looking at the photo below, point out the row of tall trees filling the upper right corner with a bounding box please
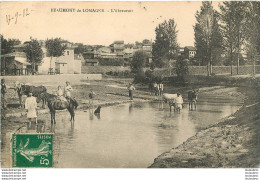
[194,1,260,75]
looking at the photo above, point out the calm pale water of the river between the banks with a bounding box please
[28,102,239,168]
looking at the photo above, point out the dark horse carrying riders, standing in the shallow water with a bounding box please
[46,93,78,124]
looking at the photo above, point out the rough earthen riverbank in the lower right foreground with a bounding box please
[150,81,260,168]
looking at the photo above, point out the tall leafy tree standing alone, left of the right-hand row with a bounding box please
[152,19,178,67]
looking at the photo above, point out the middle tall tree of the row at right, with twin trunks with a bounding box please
[220,1,247,75]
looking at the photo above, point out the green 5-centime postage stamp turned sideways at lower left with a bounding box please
[12,134,53,167]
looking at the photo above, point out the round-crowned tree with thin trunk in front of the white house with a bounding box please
[45,38,67,68]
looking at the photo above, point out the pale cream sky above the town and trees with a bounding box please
[0,1,218,46]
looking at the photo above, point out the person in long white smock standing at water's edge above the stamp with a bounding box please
[25,92,37,123]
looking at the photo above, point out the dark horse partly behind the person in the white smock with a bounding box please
[19,85,47,108]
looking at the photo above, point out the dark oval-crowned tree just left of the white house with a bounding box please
[24,39,43,72]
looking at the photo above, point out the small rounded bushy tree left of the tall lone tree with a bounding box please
[130,51,148,73]
